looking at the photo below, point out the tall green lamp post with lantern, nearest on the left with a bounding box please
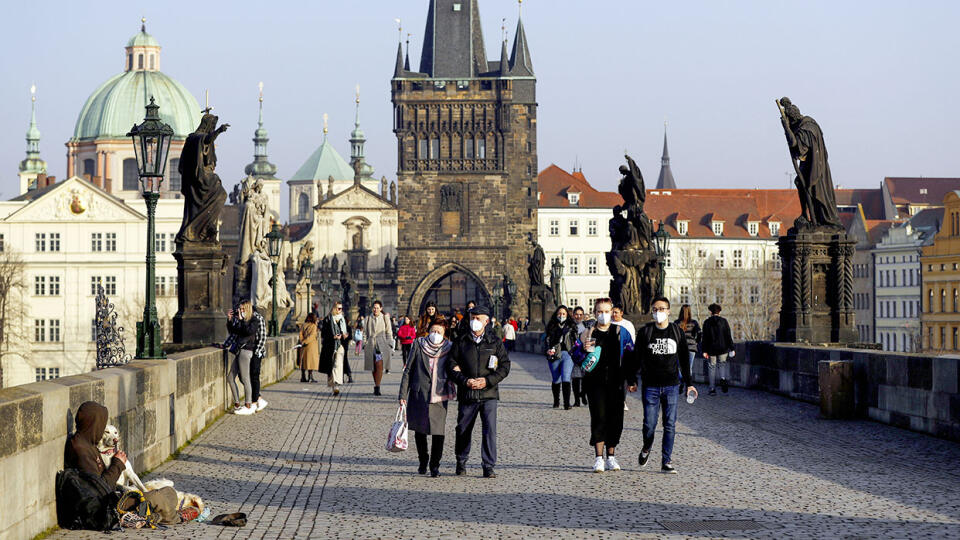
[127,96,173,359]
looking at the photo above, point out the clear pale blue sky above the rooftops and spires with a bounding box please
[0,0,960,211]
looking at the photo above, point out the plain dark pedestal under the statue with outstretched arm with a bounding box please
[173,242,228,344]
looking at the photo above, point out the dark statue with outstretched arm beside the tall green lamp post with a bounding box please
[177,111,230,242]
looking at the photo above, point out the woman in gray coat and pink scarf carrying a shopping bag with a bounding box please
[400,322,457,478]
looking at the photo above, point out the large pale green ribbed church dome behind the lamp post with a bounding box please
[72,70,200,141]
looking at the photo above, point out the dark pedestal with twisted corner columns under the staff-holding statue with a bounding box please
[777,228,859,343]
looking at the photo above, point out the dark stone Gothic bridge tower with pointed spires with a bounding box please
[391,0,537,317]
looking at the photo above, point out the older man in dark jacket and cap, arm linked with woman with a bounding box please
[447,306,510,478]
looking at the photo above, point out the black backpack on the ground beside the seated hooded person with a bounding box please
[56,469,120,531]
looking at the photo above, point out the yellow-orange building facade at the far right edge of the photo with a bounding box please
[920,191,960,354]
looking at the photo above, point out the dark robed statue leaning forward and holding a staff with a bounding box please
[777,97,843,229]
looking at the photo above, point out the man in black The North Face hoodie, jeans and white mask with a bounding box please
[636,296,697,474]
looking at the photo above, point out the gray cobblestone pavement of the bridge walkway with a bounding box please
[55,348,960,539]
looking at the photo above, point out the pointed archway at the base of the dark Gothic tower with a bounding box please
[407,263,491,318]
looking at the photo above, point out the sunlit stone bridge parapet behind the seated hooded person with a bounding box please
[0,335,297,539]
